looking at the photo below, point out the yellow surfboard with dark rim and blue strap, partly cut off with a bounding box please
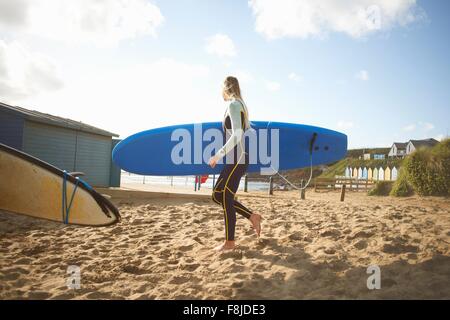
[0,143,120,226]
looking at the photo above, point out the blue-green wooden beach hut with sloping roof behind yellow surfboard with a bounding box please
[0,102,120,187]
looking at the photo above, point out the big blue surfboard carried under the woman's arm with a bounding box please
[112,121,347,176]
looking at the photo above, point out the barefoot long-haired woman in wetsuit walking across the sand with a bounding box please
[209,77,261,251]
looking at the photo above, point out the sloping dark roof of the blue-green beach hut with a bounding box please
[0,102,119,137]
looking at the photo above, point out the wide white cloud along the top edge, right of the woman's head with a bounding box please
[249,0,425,39]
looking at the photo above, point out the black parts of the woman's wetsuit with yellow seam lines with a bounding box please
[212,100,252,240]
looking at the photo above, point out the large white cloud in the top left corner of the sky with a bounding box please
[0,0,164,46]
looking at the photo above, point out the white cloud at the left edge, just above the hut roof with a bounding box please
[0,40,63,101]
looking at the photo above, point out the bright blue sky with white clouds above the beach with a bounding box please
[0,0,450,148]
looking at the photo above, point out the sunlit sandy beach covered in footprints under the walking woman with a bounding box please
[0,191,450,299]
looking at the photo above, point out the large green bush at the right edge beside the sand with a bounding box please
[404,139,450,196]
